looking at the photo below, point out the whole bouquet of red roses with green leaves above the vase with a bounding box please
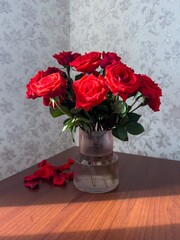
[26,51,162,141]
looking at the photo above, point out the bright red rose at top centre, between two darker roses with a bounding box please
[70,52,101,73]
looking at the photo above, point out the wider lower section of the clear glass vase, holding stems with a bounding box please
[73,153,119,193]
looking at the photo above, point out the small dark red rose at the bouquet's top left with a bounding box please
[53,51,81,67]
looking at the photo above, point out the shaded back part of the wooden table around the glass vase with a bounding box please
[0,148,180,206]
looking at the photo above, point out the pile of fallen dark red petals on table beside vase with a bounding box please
[24,159,74,189]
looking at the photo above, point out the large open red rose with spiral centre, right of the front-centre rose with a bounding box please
[106,63,140,101]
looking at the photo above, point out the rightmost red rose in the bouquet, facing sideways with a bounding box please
[136,74,162,112]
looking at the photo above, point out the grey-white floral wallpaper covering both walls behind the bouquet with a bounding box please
[0,0,180,179]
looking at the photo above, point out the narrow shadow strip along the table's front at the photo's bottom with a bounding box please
[0,224,180,240]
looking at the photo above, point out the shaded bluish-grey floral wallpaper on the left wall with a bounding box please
[0,0,71,179]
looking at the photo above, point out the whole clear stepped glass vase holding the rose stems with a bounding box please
[74,129,119,193]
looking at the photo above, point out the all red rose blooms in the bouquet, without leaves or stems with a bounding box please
[26,51,162,111]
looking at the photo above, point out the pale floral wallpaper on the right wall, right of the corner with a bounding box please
[70,0,180,160]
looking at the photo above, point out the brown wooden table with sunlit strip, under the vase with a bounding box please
[0,147,180,240]
